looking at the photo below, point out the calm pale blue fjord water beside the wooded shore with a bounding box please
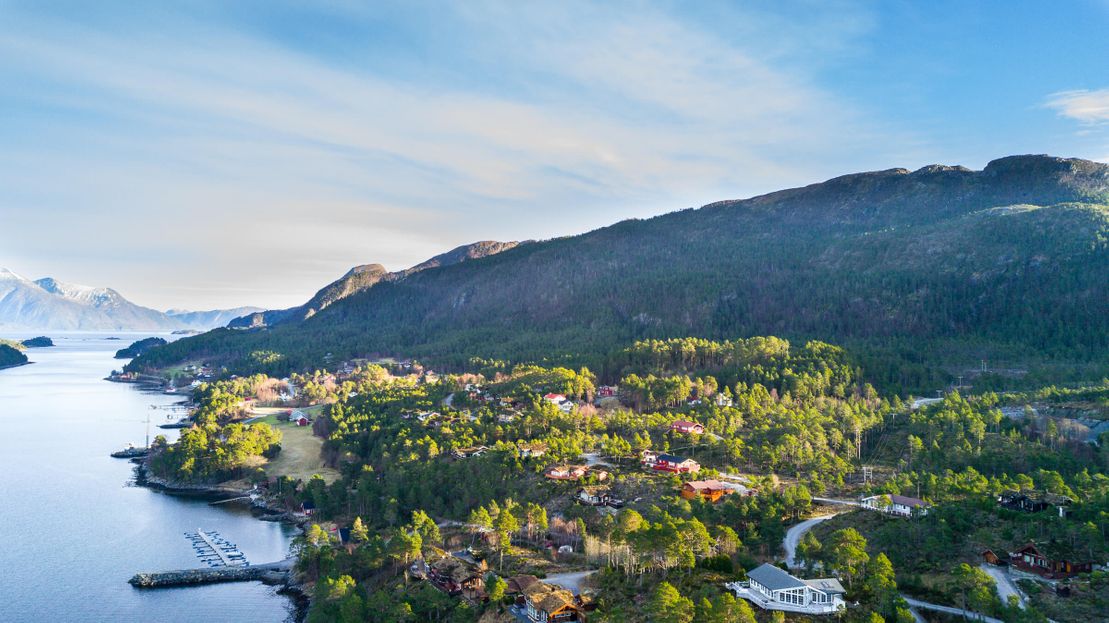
[0,334,293,622]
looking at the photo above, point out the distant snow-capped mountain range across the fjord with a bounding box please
[0,268,258,331]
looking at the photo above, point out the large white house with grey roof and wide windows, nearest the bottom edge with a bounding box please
[724,563,847,614]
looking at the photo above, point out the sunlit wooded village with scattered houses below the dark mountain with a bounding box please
[136,334,1109,622]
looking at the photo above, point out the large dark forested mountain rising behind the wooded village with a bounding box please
[132,156,1109,386]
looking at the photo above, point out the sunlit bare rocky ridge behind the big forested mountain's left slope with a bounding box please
[228,241,520,328]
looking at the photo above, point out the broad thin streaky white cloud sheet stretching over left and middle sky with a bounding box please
[0,3,914,307]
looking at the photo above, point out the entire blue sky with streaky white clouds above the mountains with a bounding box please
[0,0,1109,308]
